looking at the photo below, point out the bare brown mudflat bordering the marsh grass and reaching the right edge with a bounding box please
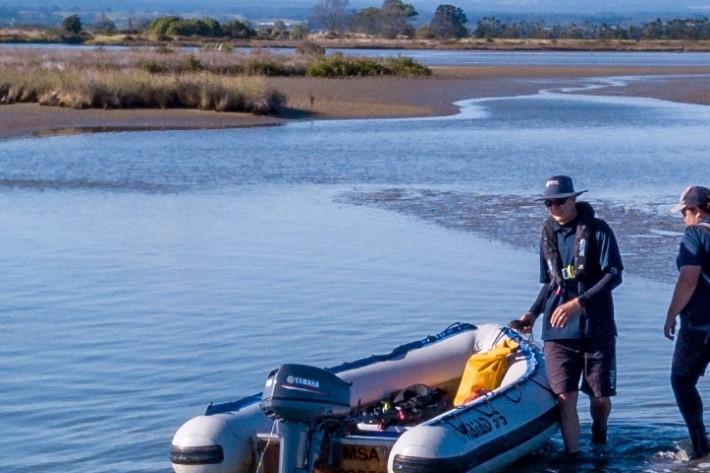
[0,66,710,139]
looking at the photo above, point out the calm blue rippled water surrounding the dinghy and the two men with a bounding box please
[0,72,710,473]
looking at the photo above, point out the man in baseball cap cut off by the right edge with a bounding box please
[663,186,710,459]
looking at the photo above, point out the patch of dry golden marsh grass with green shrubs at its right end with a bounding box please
[0,48,431,114]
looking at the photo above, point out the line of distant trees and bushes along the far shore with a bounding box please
[0,0,710,42]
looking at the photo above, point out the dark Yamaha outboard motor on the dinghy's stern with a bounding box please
[261,364,350,473]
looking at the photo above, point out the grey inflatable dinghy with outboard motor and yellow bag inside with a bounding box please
[170,323,559,473]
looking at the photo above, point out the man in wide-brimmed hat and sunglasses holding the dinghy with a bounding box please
[518,176,623,455]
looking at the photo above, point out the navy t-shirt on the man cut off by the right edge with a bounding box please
[676,218,710,326]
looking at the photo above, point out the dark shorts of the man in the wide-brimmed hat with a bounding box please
[544,338,616,397]
